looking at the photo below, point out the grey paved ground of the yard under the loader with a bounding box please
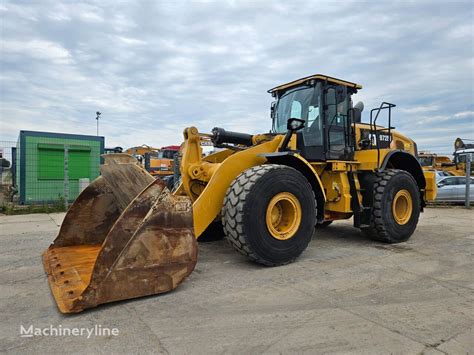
[0,208,474,354]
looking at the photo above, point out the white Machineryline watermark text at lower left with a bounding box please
[20,324,119,339]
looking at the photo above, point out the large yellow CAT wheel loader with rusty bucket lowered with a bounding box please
[43,75,436,313]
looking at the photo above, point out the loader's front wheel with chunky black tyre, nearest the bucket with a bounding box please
[222,164,316,266]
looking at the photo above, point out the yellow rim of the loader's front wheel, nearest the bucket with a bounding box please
[266,192,301,240]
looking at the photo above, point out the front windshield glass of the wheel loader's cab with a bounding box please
[273,83,321,133]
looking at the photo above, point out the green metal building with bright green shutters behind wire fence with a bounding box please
[0,131,104,205]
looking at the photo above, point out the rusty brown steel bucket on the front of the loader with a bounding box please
[43,154,197,313]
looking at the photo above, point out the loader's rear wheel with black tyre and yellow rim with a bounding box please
[362,169,421,243]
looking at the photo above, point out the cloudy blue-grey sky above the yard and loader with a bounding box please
[0,0,474,153]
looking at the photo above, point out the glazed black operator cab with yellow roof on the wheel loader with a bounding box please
[268,74,363,161]
